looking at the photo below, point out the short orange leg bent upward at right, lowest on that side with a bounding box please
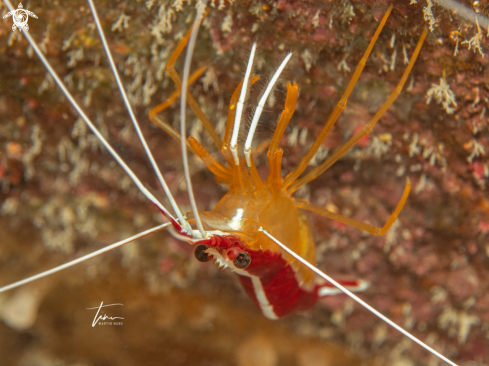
[294,178,411,236]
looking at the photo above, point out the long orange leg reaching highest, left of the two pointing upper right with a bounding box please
[285,5,392,187]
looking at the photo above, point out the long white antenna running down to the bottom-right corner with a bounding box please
[258,227,457,366]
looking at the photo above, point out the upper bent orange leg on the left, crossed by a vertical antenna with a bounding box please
[166,28,222,149]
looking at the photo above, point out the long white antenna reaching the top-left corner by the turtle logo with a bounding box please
[3,0,180,233]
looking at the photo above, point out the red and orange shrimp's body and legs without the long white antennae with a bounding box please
[150,6,427,319]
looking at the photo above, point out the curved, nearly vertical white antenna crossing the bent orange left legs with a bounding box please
[180,0,207,238]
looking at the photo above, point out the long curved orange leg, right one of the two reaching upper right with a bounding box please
[288,29,427,194]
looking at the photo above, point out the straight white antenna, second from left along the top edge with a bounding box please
[88,0,192,234]
